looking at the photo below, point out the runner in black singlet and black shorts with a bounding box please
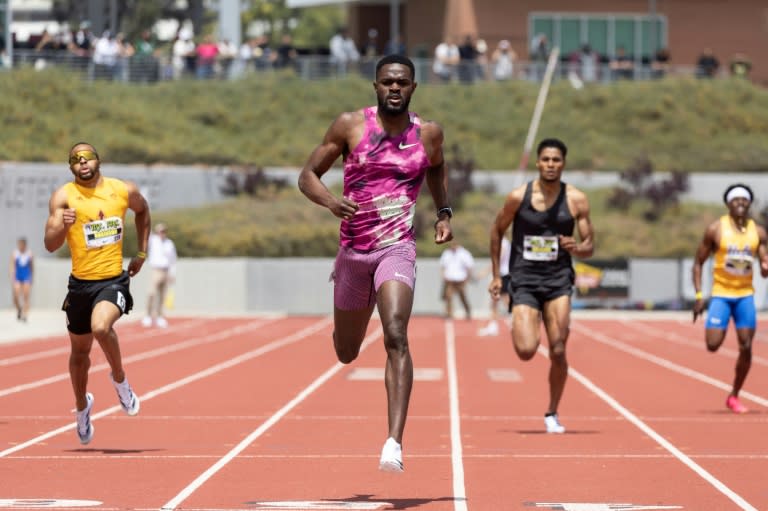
[488,138,594,433]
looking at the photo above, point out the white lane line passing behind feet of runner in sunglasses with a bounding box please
[0,318,331,458]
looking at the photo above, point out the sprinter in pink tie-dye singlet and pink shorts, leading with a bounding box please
[299,55,453,472]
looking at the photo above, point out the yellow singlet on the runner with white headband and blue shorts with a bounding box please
[712,215,760,298]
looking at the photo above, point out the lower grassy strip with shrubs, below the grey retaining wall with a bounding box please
[120,189,725,259]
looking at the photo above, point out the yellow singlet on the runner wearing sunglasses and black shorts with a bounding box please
[64,177,128,280]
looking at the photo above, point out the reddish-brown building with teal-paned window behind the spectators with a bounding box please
[349,0,768,85]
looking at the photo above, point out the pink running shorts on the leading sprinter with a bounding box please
[331,241,416,311]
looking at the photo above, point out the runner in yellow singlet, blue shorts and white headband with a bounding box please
[693,183,768,413]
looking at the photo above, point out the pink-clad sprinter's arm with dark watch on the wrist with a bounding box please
[421,121,453,244]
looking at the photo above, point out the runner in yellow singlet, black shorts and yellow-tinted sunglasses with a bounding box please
[45,142,151,444]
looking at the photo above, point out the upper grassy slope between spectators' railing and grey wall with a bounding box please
[0,70,768,171]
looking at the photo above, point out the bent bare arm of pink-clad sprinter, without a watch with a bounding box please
[299,112,364,220]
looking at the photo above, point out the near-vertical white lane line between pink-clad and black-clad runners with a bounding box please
[445,319,467,511]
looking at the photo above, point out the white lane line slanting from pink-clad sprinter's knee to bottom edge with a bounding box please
[160,328,382,511]
